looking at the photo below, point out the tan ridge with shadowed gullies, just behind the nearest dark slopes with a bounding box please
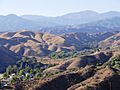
[45,52,112,72]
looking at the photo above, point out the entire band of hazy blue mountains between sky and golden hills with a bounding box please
[0,11,120,34]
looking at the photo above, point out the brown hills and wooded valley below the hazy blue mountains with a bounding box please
[0,30,120,90]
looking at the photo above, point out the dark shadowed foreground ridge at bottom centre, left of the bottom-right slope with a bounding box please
[15,67,95,90]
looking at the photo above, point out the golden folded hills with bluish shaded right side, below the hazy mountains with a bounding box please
[0,30,116,56]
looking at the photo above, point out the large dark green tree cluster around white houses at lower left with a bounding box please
[4,57,48,82]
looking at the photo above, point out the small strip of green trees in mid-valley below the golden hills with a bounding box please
[49,51,78,59]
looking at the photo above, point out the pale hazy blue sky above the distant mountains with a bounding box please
[0,0,120,16]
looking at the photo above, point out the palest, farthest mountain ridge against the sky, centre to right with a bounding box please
[22,11,120,26]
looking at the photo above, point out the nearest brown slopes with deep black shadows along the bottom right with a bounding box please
[15,67,120,90]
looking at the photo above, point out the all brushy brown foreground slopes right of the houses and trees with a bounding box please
[14,49,120,90]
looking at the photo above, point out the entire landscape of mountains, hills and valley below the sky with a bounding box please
[0,10,120,90]
